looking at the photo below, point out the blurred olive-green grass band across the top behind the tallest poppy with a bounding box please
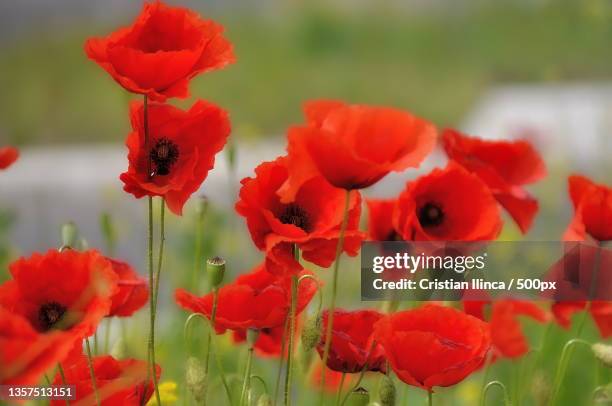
[0,0,612,145]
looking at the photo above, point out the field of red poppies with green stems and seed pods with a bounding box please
[0,1,612,406]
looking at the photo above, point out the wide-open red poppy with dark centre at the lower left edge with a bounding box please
[0,249,117,340]
